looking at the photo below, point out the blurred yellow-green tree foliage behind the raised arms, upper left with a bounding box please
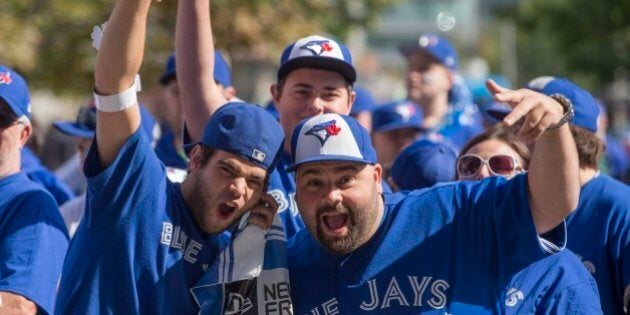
[0,0,396,95]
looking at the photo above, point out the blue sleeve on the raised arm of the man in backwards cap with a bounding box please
[84,128,167,230]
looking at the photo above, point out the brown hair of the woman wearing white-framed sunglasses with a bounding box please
[459,124,531,170]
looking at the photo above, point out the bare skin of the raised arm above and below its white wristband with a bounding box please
[94,0,151,167]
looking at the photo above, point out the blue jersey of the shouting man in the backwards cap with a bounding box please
[55,129,228,314]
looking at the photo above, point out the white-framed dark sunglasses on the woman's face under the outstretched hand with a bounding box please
[457,154,522,178]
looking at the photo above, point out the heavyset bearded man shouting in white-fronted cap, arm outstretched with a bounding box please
[287,81,601,314]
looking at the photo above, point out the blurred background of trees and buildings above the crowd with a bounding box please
[0,0,630,168]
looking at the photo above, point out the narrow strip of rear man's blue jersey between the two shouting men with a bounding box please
[267,152,304,238]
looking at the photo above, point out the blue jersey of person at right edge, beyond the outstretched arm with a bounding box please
[567,175,630,314]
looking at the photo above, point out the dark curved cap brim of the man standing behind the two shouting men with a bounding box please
[278,56,357,84]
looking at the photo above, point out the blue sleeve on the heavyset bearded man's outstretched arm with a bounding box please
[458,174,566,277]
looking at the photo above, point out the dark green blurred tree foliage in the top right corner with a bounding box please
[516,0,630,90]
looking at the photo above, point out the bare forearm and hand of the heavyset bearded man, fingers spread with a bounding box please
[487,80,580,234]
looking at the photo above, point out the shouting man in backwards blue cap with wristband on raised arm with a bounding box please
[55,0,283,314]
